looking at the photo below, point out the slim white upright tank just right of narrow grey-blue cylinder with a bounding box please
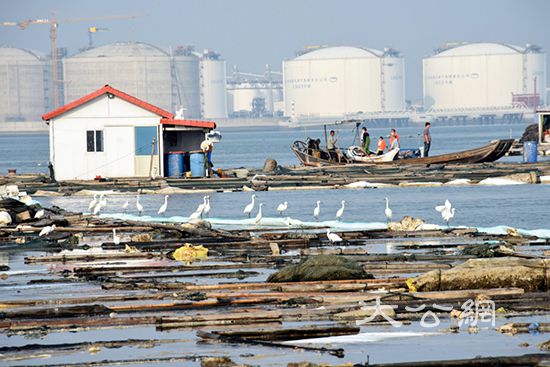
[200,52,227,119]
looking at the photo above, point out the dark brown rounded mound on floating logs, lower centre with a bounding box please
[267,255,373,283]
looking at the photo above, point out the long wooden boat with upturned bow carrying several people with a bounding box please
[291,139,514,166]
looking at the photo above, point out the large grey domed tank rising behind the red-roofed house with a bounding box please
[63,42,172,111]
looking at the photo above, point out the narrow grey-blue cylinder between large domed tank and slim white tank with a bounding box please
[172,49,201,118]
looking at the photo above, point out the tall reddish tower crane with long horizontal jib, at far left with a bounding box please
[0,15,139,108]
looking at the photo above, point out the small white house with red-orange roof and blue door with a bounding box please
[42,85,216,180]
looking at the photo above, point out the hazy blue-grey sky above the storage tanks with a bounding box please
[0,0,550,99]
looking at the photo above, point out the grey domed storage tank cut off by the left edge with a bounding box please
[0,47,47,121]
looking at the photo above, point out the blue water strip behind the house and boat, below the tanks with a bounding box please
[0,124,536,175]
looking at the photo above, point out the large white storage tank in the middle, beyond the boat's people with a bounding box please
[283,47,405,119]
